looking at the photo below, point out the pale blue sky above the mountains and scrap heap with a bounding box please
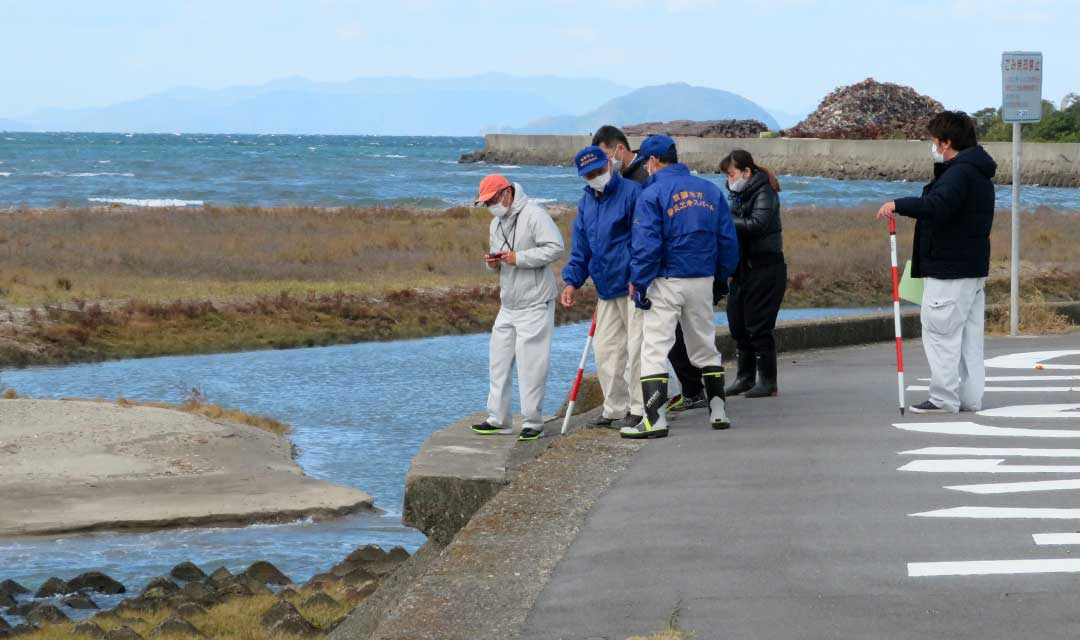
[0,0,1080,118]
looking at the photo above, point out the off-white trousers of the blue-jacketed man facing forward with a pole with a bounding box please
[593,296,645,419]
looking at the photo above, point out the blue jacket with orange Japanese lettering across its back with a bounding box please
[630,163,739,291]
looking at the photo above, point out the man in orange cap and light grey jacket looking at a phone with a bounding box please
[472,174,564,440]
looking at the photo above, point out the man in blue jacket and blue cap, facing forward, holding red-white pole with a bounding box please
[561,147,643,428]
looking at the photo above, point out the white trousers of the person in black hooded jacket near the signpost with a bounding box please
[921,277,986,413]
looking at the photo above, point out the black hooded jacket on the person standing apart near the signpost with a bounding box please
[896,147,998,280]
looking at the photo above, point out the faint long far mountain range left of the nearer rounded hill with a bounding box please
[8,73,630,136]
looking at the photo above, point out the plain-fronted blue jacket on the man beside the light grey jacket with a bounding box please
[563,172,642,300]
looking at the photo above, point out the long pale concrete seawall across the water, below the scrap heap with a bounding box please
[462,134,1080,187]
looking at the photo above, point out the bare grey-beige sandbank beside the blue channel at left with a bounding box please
[0,399,373,536]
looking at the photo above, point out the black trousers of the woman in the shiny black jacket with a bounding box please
[728,261,787,352]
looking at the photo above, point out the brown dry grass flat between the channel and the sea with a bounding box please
[0,207,1080,365]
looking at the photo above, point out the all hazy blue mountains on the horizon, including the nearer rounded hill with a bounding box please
[0,73,786,136]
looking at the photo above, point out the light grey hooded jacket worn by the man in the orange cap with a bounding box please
[488,182,564,311]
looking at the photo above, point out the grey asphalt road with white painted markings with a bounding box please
[523,333,1080,640]
